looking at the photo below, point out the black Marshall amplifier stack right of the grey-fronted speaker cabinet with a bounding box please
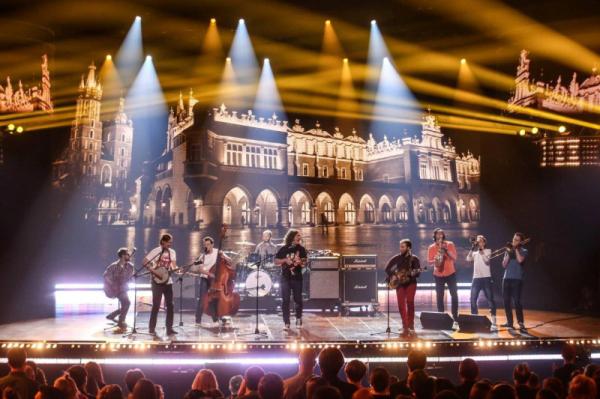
[342,255,378,307]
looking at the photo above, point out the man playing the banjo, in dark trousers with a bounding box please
[143,234,177,335]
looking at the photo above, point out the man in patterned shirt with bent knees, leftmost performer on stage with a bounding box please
[103,248,134,330]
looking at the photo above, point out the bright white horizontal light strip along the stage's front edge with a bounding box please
[0,353,584,366]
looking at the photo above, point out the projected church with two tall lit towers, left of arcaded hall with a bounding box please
[53,64,133,224]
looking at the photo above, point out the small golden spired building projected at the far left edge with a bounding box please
[0,55,53,114]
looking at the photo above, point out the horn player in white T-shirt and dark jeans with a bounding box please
[467,235,496,326]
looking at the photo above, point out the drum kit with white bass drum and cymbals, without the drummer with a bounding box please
[233,241,279,298]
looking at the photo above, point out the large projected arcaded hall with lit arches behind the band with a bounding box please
[139,103,480,228]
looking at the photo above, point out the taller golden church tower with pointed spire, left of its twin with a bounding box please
[68,63,102,180]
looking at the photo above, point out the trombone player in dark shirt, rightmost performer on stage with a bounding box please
[502,232,527,330]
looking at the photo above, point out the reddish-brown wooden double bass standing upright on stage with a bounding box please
[203,225,240,319]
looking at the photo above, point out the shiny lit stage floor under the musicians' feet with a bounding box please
[0,310,600,343]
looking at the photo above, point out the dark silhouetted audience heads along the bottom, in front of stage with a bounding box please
[0,345,600,399]
